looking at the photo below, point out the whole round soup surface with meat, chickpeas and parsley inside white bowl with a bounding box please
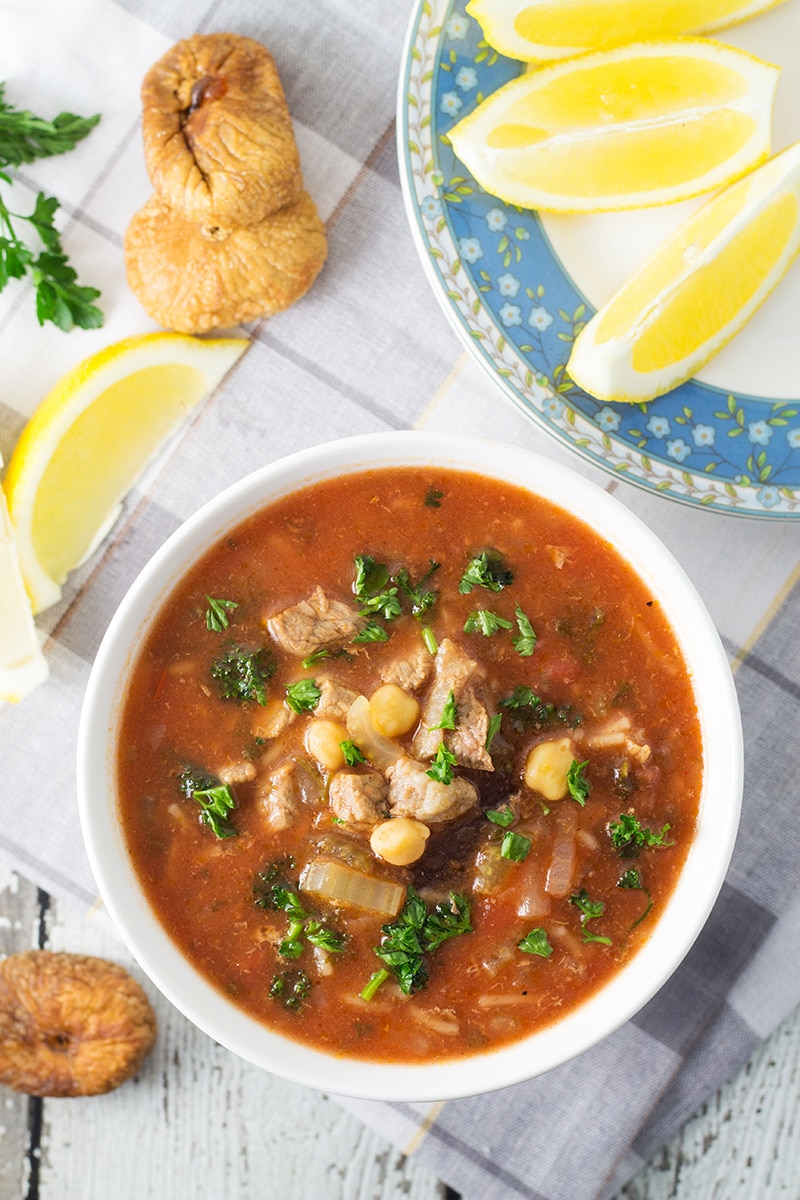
[119,468,702,1062]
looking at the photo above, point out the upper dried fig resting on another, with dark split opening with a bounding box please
[142,34,302,226]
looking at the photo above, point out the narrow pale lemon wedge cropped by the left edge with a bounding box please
[0,472,48,703]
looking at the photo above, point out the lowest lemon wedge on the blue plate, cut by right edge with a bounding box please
[567,142,800,402]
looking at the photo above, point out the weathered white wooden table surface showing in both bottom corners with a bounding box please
[0,865,800,1200]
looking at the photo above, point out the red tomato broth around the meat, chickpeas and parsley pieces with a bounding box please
[119,468,703,1062]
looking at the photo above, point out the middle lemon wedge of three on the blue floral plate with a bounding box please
[449,37,780,212]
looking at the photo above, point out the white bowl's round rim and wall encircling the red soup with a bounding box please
[78,432,742,1100]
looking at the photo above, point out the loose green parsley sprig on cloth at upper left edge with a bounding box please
[0,83,103,331]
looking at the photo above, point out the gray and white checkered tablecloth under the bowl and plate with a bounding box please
[0,0,800,1200]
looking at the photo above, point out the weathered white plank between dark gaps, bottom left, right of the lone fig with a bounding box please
[20,901,445,1200]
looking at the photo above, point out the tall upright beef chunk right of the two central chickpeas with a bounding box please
[414,637,494,770]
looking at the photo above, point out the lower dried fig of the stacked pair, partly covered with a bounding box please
[125,192,327,334]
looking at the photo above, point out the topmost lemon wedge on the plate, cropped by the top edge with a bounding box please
[467,0,782,62]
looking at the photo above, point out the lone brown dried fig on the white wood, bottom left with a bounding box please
[0,950,156,1096]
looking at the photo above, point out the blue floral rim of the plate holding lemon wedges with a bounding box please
[397,0,800,520]
